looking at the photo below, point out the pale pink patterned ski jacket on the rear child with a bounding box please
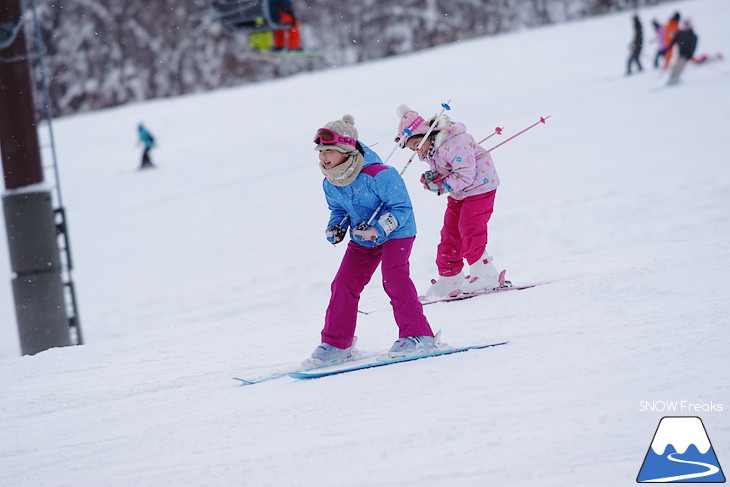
[419,122,499,200]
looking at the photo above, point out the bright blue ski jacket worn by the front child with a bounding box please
[322,142,416,247]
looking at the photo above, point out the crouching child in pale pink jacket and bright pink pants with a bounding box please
[396,105,500,299]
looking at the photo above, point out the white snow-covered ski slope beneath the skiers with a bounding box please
[0,0,730,487]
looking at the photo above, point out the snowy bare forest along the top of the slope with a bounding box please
[26,0,672,115]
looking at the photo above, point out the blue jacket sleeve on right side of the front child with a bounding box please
[366,167,413,237]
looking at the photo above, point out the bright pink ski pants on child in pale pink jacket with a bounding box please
[436,190,497,276]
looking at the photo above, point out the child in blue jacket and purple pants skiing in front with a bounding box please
[306,115,438,365]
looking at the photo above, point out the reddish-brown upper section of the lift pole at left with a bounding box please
[0,0,43,189]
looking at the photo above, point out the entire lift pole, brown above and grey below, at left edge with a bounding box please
[0,0,72,354]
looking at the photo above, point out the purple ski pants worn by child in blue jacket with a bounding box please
[322,237,433,348]
